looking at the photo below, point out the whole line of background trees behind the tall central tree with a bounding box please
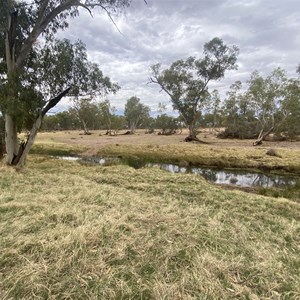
[44,68,300,144]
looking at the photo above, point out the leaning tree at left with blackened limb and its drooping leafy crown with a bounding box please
[1,39,119,167]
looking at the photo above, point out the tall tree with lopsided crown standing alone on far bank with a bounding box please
[150,38,239,140]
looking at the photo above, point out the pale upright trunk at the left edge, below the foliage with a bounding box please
[5,114,19,165]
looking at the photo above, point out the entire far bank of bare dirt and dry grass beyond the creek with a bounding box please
[32,131,300,175]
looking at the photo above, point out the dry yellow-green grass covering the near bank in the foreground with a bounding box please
[0,158,300,299]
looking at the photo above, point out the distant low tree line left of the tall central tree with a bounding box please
[42,96,182,135]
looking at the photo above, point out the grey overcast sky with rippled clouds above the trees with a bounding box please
[55,0,300,113]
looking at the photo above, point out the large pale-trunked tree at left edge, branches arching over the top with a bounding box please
[0,0,134,167]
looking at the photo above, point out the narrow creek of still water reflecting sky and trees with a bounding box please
[56,156,299,188]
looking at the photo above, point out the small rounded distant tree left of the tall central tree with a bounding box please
[124,96,150,133]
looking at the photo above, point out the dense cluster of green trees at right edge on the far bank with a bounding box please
[223,68,300,138]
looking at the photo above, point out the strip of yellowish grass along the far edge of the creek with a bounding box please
[97,143,300,174]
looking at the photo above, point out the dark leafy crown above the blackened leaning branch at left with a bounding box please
[36,39,119,97]
